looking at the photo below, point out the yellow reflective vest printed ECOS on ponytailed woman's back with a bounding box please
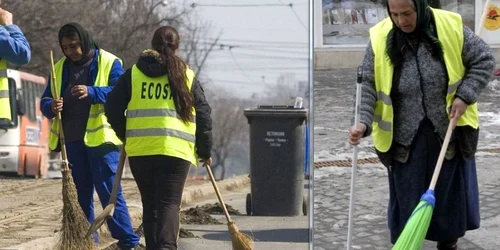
[125,65,198,166]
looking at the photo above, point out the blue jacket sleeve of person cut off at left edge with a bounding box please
[0,24,31,65]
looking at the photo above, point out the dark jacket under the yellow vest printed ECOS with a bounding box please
[104,51,212,158]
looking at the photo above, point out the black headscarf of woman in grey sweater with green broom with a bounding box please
[387,0,443,67]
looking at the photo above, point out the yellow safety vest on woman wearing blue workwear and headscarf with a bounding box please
[49,49,122,150]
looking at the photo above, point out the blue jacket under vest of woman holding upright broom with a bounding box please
[40,49,124,119]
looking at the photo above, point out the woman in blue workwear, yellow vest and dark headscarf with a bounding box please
[40,23,139,249]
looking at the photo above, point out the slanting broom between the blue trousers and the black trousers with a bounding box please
[86,146,126,237]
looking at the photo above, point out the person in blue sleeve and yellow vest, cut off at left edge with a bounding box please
[0,1,31,124]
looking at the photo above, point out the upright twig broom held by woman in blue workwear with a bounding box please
[50,50,97,250]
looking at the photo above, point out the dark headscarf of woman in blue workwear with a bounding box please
[59,22,98,65]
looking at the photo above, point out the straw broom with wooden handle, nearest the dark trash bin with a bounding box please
[205,164,254,250]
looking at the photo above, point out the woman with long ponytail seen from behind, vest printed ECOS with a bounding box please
[104,23,212,250]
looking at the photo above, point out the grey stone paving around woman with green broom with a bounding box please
[313,69,500,250]
